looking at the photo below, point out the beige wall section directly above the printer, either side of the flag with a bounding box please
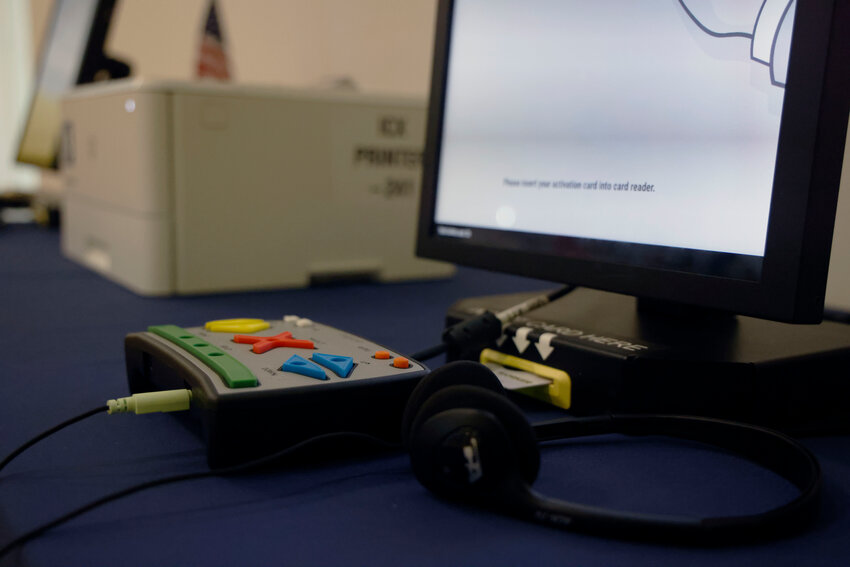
[99,0,436,96]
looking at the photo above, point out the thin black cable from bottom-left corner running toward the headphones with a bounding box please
[0,431,400,559]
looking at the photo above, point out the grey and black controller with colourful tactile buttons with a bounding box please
[124,315,428,467]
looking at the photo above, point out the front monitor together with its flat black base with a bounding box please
[417,0,850,430]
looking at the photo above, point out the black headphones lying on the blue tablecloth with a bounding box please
[402,361,821,545]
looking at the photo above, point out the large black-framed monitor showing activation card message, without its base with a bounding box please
[417,0,850,323]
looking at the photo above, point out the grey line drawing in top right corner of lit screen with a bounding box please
[679,0,796,88]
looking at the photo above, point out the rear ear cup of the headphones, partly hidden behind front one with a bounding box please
[401,360,505,445]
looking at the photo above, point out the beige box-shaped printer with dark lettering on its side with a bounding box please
[62,81,453,295]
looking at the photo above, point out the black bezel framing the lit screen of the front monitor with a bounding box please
[416,0,850,323]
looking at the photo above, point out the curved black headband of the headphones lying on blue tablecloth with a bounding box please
[514,415,821,544]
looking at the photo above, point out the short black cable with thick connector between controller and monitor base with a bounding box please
[410,285,576,361]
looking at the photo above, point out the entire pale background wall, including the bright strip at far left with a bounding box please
[11,0,436,192]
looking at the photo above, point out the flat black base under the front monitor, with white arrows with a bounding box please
[447,288,850,433]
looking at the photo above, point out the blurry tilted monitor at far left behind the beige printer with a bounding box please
[17,0,130,168]
